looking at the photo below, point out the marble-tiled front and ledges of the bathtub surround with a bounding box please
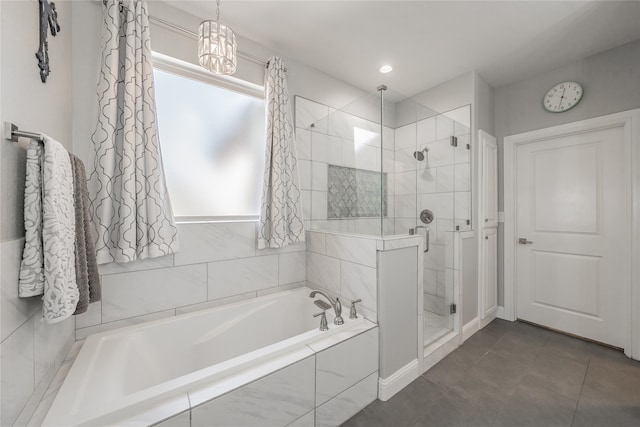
[30,322,378,427]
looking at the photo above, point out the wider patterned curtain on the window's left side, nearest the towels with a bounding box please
[89,0,178,264]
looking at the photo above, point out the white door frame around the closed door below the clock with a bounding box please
[499,108,640,360]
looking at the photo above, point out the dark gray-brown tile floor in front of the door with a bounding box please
[343,320,640,427]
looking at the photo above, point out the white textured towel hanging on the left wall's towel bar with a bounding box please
[19,136,79,323]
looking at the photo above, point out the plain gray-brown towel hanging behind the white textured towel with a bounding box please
[69,153,102,315]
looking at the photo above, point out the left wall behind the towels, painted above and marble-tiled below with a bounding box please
[0,1,74,426]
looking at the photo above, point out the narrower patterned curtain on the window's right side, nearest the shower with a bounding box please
[258,57,304,249]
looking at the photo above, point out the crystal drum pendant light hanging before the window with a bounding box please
[198,0,237,75]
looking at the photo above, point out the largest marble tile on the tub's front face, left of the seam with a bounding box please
[189,357,315,427]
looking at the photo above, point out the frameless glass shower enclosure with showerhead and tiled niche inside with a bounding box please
[295,87,471,346]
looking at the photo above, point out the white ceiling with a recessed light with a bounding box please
[169,0,640,96]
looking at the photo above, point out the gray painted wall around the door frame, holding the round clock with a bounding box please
[495,40,640,305]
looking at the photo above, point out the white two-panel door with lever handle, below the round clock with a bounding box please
[514,127,627,347]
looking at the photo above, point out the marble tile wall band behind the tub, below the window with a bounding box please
[76,221,306,339]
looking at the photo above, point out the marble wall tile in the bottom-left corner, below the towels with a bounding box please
[0,319,35,426]
